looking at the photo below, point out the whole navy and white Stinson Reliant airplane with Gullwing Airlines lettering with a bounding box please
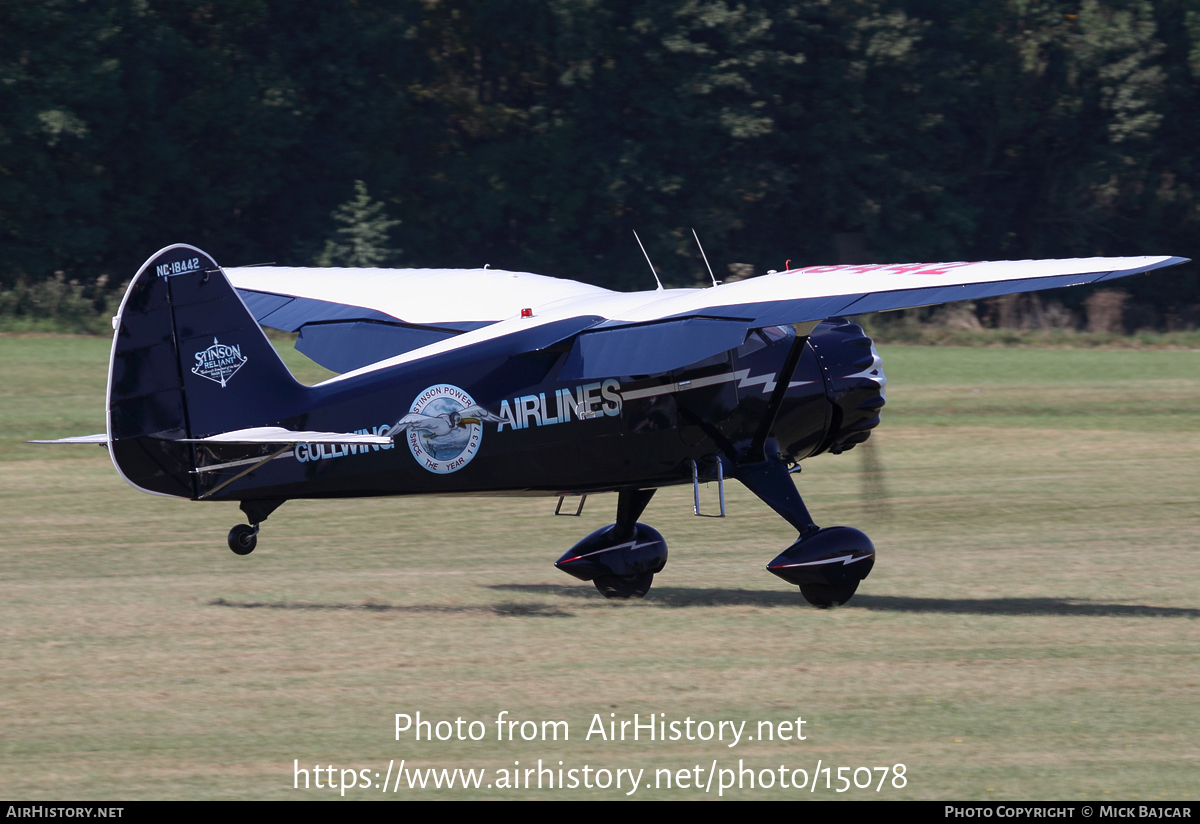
[30,243,1184,607]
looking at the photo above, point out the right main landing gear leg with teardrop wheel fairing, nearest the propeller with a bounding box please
[734,461,875,609]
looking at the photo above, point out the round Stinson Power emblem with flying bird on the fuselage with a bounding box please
[401,384,490,475]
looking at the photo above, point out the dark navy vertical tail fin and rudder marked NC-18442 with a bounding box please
[108,243,308,498]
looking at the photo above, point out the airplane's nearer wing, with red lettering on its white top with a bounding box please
[304,257,1187,381]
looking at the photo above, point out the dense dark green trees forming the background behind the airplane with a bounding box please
[0,0,1200,325]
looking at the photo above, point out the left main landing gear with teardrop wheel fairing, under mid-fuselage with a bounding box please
[554,489,667,599]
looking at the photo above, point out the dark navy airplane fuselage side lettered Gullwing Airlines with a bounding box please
[193,327,882,500]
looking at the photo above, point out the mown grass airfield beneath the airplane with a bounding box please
[0,336,1200,800]
